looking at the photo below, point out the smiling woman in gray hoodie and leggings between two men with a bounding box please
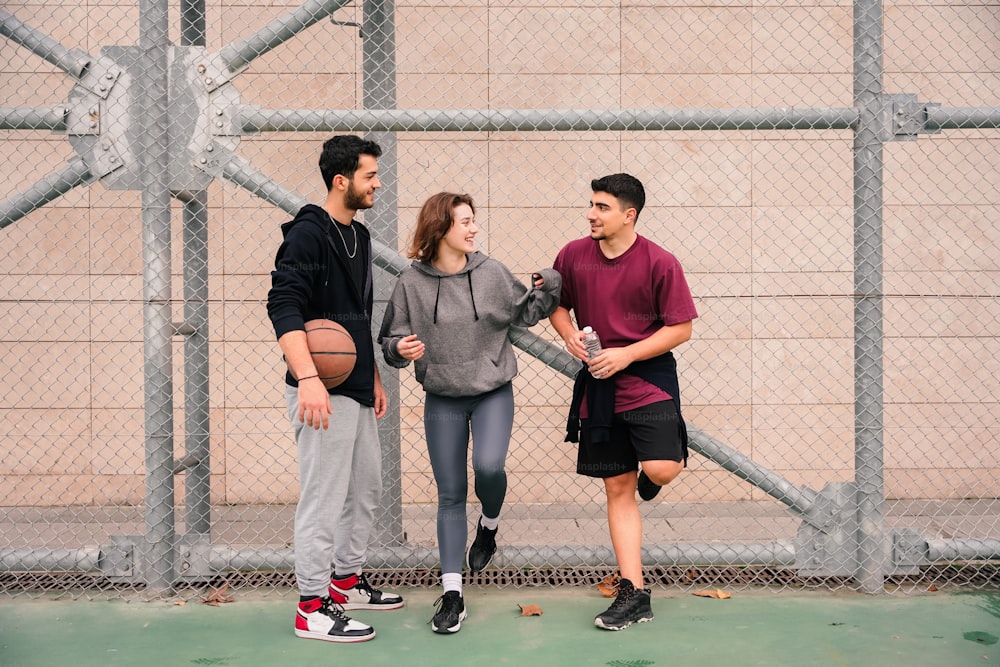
[379,192,561,634]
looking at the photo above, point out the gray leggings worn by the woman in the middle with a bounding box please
[424,382,514,573]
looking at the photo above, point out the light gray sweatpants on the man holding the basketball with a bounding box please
[285,386,382,596]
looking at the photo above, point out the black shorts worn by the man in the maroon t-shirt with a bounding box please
[576,400,687,478]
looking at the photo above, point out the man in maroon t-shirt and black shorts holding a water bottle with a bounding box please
[550,174,698,630]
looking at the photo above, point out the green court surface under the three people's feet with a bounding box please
[0,587,1000,667]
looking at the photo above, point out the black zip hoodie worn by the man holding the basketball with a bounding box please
[267,204,375,407]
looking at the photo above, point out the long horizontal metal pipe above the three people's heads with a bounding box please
[235,106,858,132]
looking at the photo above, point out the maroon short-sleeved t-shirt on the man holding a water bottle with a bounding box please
[552,236,698,417]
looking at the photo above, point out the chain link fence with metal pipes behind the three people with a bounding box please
[0,0,1000,597]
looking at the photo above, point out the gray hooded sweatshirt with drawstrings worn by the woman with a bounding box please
[378,252,562,396]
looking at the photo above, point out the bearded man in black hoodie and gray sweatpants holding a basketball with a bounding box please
[267,135,403,642]
